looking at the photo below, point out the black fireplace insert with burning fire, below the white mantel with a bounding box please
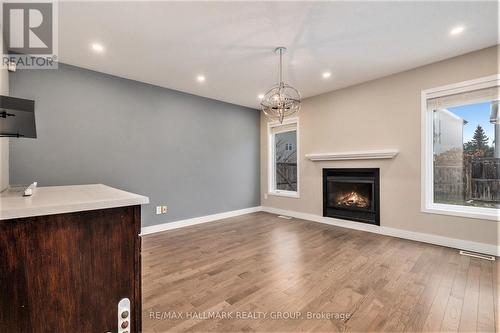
[323,169,380,225]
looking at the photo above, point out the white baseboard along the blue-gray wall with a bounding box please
[141,206,262,235]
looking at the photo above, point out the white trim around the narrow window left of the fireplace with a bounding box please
[267,117,300,199]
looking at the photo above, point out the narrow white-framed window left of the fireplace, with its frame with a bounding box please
[268,119,299,197]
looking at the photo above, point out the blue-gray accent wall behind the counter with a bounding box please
[10,64,260,226]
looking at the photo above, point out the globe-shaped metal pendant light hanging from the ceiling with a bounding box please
[260,47,300,123]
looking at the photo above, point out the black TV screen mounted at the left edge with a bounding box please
[0,96,36,138]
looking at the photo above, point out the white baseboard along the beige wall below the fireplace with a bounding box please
[262,207,500,257]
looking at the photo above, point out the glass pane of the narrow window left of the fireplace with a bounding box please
[273,129,297,192]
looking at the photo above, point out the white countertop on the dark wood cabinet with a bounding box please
[0,184,149,220]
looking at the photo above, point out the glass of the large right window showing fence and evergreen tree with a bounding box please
[431,94,500,209]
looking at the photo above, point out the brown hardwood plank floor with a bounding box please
[142,212,500,332]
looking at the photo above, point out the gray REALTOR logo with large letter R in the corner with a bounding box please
[2,0,57,69]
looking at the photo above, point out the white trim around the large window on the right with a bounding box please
[421,74,500,222]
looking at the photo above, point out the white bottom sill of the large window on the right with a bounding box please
[422,204,500,222]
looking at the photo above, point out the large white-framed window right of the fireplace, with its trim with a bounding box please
[422,76,500,221]
